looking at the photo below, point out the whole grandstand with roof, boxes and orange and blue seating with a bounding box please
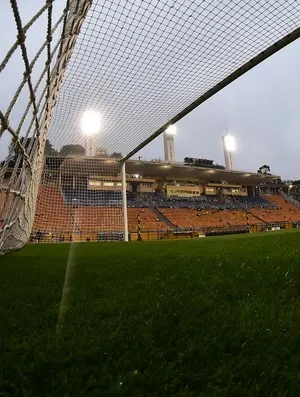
[4,157,292,242]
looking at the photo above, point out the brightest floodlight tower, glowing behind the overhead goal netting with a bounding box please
[81,110,101,156]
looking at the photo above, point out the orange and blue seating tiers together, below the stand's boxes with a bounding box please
[31,181,300,241]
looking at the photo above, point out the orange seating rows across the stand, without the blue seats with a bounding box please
[29,186,300,239]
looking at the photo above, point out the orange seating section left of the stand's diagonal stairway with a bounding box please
[33,186,169,239]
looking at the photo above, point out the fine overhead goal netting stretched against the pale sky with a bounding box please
[50,0,300,156]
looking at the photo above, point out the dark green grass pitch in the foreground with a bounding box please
[0,233,300,397]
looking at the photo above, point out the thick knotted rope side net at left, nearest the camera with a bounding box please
[0,0,90,252]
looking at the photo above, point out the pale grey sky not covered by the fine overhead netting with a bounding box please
[0,0,300,179]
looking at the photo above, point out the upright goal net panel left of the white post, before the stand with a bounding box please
[31,157,124,242]
